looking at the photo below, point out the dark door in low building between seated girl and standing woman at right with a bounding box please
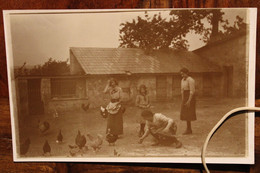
[156,76,167,101]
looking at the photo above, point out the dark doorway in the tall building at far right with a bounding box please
[224,66,233,97]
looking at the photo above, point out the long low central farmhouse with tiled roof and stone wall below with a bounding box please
[70,48,221,103]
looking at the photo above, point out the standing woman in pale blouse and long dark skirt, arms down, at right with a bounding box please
[180,68,197,135]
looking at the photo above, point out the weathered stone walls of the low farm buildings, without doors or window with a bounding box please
[18,73,220,114]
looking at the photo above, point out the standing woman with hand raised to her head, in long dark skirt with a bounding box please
[104,78,123,135]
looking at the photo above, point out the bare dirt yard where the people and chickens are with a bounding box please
[19,98,246,157]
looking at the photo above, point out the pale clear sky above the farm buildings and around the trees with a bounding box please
[10,9,246,66]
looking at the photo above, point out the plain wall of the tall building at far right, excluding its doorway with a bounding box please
[194,35,248,97]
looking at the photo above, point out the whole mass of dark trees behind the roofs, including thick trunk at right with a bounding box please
[119,9,246,52]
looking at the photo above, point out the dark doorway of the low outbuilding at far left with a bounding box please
[28,79,44,115]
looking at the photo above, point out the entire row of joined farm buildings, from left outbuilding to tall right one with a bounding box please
[16,35,246,114]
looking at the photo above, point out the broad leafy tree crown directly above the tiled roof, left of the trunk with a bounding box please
[120,11,194,50]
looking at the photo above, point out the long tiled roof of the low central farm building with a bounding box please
[70,47,219,74]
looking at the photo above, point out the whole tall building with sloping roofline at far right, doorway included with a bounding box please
[193,31,249,97]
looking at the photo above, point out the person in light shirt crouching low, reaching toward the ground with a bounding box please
[139,110,182,148]
